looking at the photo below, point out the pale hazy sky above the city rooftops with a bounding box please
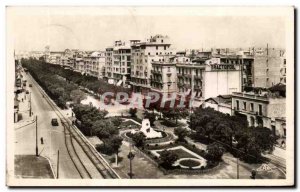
[7,8,285,51]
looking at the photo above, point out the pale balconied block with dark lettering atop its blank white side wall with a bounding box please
[150,52,242,108]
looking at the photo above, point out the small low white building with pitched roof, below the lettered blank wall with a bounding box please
[203,95,232,115]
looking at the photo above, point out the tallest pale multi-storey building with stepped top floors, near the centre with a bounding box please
[130,35,175,94]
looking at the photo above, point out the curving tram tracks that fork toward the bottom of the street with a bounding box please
[28,74,120,179]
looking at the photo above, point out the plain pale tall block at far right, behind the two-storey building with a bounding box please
[253,47,286,88]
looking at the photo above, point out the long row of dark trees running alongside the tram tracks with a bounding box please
[22,59,122,160]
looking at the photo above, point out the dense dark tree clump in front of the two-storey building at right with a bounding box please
[189,108,276,162]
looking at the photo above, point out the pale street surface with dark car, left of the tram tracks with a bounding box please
[15,73,102,179]
